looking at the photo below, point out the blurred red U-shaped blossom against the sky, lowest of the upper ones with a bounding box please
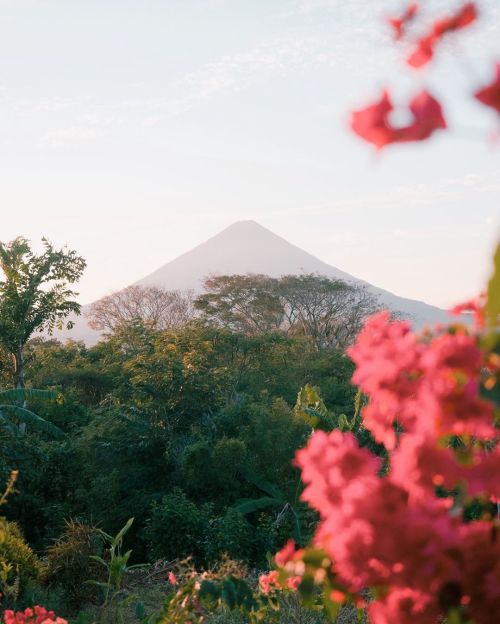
[351,91,446,149]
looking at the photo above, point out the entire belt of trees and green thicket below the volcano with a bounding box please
[0,239,377,612]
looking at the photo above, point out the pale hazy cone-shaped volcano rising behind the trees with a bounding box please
[56,221,448,344]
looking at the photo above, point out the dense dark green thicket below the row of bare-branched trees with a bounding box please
[0,322,354,565]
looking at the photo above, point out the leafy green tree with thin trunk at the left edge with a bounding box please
[0,237,86,388]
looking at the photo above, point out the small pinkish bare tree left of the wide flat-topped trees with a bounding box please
[87,286,195,332]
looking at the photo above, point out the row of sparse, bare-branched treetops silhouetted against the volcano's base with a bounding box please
[87,274,378,349]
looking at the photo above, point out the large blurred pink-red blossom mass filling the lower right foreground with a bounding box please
[292,306,500,624]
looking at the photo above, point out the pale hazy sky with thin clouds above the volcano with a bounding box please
[0,0,500,306]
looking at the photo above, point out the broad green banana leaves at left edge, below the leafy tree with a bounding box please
[0,388,64,439]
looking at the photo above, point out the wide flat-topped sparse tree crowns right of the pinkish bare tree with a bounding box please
[194,273,378,350]
